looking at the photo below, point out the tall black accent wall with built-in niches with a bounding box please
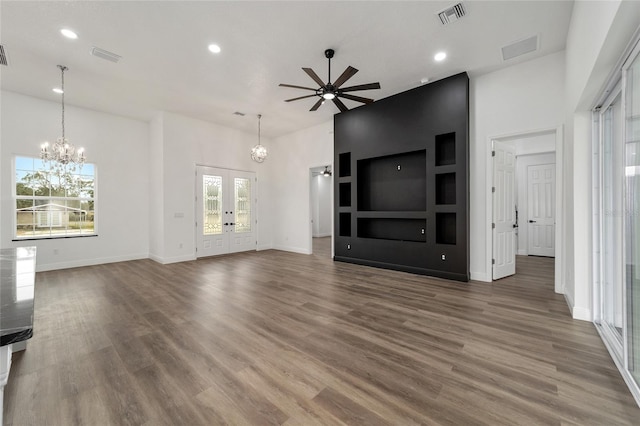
[334,73,469,281]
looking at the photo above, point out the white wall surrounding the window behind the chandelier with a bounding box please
[0,92,149,271]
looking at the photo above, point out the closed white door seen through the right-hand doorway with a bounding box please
[527,164,556,257]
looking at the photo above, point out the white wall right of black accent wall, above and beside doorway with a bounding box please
[469,52,564,281]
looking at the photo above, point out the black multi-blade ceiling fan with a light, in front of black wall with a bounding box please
[280,49,380,112]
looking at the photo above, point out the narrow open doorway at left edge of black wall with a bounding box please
[309,165,333,257]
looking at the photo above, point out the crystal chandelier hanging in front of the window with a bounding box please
[40,65,85,176]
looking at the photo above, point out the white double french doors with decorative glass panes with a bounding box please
[196,166,257,257]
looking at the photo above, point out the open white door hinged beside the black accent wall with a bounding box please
[492,141,516,280]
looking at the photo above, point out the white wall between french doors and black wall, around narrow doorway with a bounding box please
[269,120,333,254]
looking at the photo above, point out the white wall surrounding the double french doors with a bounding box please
[152,112,276,263]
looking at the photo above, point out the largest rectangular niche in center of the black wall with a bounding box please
[357,149,427,212]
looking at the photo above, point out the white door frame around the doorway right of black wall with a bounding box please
[485,125,565,294]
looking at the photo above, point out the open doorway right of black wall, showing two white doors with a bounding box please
[487,129,562,293]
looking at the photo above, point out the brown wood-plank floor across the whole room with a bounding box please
[4,250,640,425]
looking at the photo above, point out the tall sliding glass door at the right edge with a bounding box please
[593,35,640,403]
